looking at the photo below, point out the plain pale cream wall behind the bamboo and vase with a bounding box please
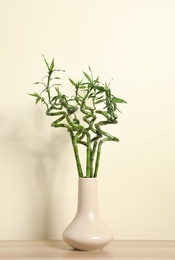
[0,0,175,239]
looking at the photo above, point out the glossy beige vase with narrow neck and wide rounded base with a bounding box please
[62,178,113,250]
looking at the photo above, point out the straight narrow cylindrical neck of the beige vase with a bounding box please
[77,178,98,211]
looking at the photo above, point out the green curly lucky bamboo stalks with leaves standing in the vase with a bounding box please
[29,56,126,178]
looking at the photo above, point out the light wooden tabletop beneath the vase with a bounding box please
[0,240,175,260]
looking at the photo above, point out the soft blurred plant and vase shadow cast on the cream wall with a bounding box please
[0,110,70,239]
